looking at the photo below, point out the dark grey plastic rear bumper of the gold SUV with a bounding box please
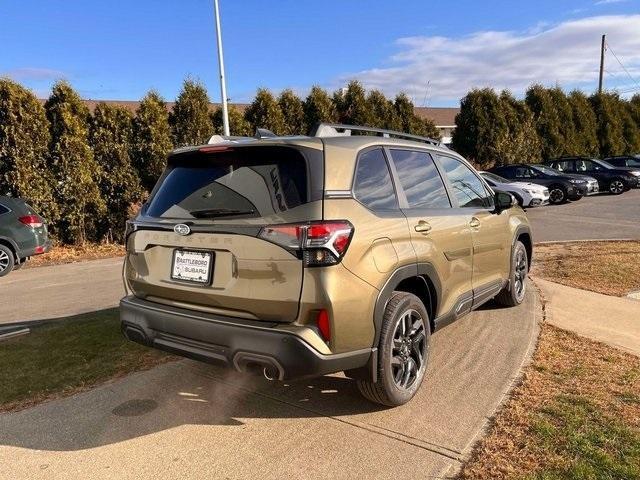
[120,296,372,380]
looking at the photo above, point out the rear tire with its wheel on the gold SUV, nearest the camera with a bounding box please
[357,292,431,407]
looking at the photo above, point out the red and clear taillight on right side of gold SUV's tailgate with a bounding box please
[259,220,353,266]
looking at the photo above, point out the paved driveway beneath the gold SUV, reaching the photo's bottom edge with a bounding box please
[0,289,541,480]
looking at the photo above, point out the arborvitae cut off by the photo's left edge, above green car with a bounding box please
[0,79,59,224]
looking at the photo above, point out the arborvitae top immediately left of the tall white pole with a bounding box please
[169,80,212,146]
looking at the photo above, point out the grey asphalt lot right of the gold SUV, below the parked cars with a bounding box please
[527,188,640,242]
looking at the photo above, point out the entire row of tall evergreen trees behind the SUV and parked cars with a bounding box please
[0,79,640,243]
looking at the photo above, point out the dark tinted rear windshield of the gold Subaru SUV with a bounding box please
[145,147,322,219]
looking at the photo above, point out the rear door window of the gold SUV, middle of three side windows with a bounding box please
[391,150,451,208]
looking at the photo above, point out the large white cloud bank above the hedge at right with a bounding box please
[340,15,640,103]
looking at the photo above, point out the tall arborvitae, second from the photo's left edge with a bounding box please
[45,82,105,244]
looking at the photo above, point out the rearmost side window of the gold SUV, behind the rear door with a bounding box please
[353,148,398,210]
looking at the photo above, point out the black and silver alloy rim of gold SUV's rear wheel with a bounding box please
[391,309,427,390]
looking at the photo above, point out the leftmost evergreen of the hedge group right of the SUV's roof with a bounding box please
[452,88,509,167]
